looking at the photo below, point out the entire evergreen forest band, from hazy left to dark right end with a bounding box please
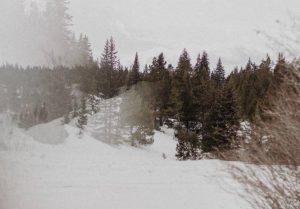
[0,34,287,160]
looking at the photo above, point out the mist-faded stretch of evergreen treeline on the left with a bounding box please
[0,39,128,128]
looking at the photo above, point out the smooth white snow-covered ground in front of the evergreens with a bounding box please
[0,117,248,209]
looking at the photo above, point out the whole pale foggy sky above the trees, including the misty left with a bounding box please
[0,0,300,71]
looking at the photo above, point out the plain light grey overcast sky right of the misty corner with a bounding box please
[0,0,300,72]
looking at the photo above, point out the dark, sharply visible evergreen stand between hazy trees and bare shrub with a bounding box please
[127,50,278,160]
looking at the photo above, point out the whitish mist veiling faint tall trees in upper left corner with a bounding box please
[0,0,90,67]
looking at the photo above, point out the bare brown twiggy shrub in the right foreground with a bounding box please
[230,64,300,209]
